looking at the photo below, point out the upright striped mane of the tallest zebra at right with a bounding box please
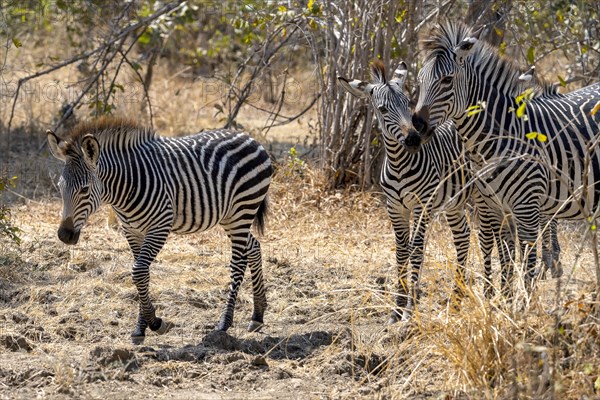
[419,20,556,97]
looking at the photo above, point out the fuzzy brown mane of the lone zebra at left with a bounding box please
[65,117,157,151]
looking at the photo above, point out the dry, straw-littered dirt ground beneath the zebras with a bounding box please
[0,152,600,399]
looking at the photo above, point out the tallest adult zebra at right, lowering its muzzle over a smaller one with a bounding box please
[415,21,600,294]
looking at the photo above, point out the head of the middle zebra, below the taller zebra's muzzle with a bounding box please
[338,60,422,153]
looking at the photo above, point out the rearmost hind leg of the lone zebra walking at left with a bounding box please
[247,234,267,332]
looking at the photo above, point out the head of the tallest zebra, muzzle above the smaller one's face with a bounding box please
[415,22,480,141]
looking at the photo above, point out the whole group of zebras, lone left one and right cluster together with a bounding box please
[47,22,600,343]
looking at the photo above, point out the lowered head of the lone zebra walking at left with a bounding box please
[46,130,102,244]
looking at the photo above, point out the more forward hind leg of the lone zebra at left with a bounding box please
[215,224,250,331]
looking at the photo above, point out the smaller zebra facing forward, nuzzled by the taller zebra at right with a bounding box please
[338,60,472,323]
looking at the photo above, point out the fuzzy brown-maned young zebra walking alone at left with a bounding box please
[46,118,273,343]
